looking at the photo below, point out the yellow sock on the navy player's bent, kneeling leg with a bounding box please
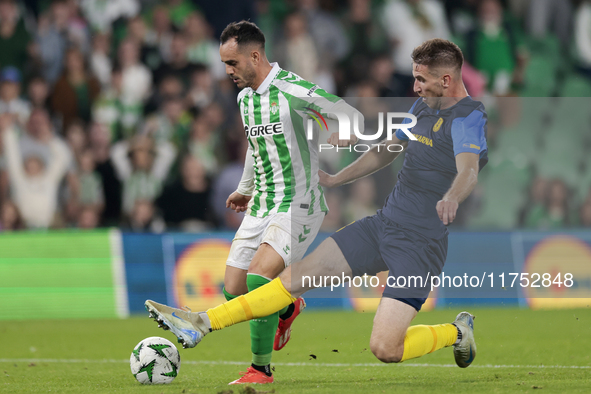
[402,323,458,361]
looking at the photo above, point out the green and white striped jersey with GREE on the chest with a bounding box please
[238,63,343,217]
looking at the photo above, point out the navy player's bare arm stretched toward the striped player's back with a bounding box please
[318,136,408,187]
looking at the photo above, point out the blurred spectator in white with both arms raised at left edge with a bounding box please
[0,115,69,228]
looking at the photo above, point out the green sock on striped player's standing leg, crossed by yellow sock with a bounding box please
[246,274,279,366]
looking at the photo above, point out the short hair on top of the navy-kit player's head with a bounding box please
[412,38,464,72]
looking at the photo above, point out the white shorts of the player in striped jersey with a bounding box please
[226,212,325,271]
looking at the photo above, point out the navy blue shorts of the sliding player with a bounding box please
[331,211,447,311]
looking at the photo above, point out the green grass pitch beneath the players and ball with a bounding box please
[0,308,591,394]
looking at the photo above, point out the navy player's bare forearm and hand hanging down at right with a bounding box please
[436,152,479,226]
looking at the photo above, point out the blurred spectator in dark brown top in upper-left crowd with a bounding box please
[50,48,101,128]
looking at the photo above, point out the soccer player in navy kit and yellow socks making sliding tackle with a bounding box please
[146,39,488,368]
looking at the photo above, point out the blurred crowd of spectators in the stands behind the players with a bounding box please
[0,0,591,231]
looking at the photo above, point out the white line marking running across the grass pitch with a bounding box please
[0,358,591,369]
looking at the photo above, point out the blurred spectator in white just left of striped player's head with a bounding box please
[183,12,226,80]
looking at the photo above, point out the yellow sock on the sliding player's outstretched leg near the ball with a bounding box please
[207,278,296,330]
